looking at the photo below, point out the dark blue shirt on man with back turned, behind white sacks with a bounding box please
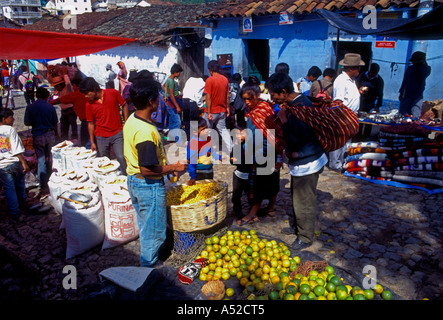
[24,99,58,137]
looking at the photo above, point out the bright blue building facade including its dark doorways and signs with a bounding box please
[203,2,443,100]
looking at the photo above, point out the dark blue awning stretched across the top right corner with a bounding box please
[315,5,443,40]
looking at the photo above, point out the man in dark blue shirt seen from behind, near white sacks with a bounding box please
[24,87,58,191]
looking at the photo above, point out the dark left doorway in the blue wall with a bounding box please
[243,39,269,81]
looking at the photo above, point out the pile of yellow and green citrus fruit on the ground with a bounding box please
[197,229,392,300]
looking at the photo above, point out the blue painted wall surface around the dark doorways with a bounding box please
[212,15,443,100]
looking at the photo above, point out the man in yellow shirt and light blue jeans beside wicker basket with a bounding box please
[123,79,187,267]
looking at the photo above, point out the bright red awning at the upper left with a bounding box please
[0,28,137,60]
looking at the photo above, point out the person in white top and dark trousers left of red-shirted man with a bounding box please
[182,76,208,140]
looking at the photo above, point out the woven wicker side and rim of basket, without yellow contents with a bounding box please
[168,180,228,232]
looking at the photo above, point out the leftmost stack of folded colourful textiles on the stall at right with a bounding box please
[343,141,393,180]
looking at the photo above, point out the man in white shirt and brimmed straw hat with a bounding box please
[328,53,365,172]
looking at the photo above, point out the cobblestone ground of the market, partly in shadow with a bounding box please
[0,92,443,300]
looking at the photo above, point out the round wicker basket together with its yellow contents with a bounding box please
[166,180,228,232]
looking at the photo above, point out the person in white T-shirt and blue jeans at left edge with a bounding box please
[0,109,29,220]
